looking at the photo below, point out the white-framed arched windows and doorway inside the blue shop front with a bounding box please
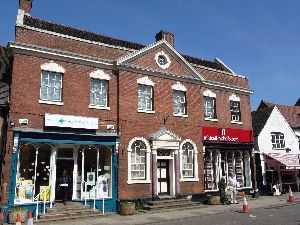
[15,143,112,203]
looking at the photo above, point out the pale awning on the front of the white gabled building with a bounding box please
[266,153,300,170]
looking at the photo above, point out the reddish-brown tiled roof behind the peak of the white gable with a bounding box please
[258,100,300,128]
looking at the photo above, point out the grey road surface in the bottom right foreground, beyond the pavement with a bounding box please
[143,204,300,225]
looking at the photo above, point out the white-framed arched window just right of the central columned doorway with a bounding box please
[180,140,198,180]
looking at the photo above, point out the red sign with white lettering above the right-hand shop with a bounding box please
[202,127,253,143]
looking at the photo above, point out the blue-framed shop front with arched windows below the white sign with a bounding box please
[9,114,118,216]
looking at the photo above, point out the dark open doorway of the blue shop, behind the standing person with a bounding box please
[55,159,74,200]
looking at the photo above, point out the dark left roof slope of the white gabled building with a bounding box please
[251,107,274,136]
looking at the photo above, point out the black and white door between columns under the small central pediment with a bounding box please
[157,160,170,195]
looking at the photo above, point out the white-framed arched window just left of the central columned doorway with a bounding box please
[128,138,151,183]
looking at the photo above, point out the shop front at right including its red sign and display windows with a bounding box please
[202,127,254,191]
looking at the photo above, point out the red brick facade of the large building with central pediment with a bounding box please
[2,4,252,205]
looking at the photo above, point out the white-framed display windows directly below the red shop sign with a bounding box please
[204,149,252,190]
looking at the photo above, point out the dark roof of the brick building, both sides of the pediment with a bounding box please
[24,15,231,73]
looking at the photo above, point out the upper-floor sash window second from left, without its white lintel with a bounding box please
[90,79,108,107]
